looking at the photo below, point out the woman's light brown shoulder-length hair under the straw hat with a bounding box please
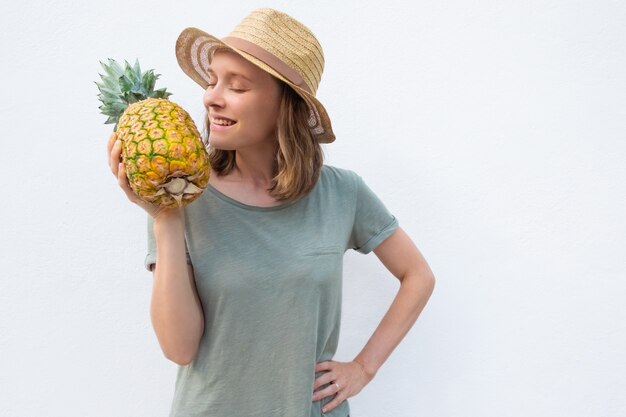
[203,49,324,201]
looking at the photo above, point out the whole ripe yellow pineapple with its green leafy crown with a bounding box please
[96,58,210,208]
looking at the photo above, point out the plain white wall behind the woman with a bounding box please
[0,0,626,417]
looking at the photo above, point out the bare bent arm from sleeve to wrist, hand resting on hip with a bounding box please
[354,228,435,378]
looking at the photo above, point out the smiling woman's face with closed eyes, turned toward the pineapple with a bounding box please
[203,51,280,150]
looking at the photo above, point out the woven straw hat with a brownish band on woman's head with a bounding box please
[176,8,335,143]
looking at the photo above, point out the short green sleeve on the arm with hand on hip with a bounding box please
[350,175,398,254]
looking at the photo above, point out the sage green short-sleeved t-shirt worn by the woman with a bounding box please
[145,165,398,417]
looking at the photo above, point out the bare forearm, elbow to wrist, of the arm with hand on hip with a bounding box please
[354,273,435,378]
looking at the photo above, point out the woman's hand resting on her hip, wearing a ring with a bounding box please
[313,360,373,413]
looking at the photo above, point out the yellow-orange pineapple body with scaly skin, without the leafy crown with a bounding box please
[116,98,210,208]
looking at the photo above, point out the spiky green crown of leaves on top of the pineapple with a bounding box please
[95,58,172,130]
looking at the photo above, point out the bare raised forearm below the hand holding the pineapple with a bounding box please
[150,216,204,364]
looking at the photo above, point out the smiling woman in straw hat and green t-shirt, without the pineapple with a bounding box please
[109,9,434,417]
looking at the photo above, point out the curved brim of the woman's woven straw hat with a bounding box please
[176,27,335,143]
